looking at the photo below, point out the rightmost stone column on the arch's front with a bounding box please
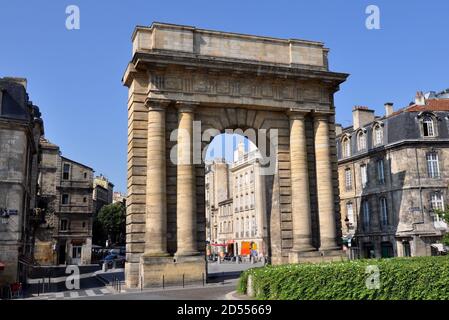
[314,114,338,251]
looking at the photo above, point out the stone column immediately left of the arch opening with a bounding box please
[176,102,198,256]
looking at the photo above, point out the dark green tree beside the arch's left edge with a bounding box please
[96,202,126,244]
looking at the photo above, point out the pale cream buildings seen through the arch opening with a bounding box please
[205,143,267,256]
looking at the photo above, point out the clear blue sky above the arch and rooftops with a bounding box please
[0,0,449,191]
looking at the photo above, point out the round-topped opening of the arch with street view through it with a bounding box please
[204,133,269,272]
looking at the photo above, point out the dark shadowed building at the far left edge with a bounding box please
[0,78,44,285]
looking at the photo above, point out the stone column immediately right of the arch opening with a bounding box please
[289,112,316,254]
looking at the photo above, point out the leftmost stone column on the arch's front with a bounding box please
[144,100,169,256]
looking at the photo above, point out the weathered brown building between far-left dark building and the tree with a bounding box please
[35,139,94,265]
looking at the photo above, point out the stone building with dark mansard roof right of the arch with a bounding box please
[337,90,449,258]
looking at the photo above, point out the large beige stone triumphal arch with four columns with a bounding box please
[123,23,347,287]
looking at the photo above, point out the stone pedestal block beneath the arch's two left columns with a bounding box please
[140,255,207,288]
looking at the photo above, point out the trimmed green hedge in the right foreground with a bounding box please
[238,257,449,300]
